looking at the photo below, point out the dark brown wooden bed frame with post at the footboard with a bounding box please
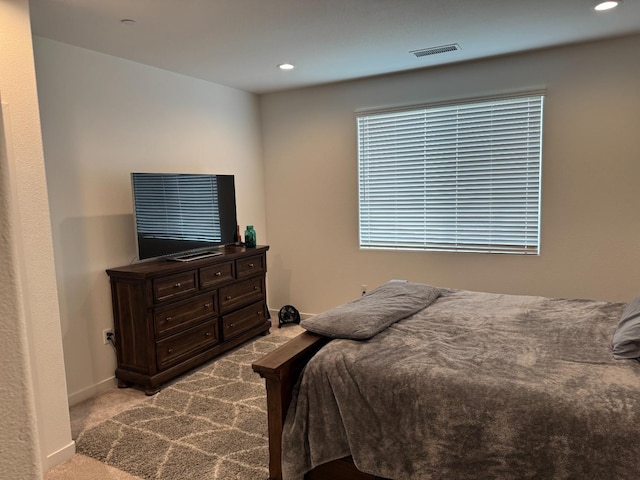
[251,332,383,480]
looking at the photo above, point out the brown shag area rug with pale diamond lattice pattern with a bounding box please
[76,328,292,480]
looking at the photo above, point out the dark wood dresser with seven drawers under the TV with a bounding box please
[107,246,271,395]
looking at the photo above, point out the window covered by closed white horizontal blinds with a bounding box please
[357,93,544,254]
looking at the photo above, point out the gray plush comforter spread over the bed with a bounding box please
[282,291,640,480]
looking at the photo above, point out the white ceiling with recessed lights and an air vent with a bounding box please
[30,0,640,94]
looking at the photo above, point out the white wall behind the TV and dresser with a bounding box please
[34,37,266,404]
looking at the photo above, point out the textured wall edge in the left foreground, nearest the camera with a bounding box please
[0,0,75,472]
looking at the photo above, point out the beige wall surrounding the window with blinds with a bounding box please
[261,32,640,313]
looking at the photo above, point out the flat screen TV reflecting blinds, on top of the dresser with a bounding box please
[131,173,238,261]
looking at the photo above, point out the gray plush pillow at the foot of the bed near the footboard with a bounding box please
[300,281,440,340]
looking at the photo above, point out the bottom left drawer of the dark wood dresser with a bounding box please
[156,321,218,369]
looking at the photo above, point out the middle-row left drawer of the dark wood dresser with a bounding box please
[153,293,217,338]
